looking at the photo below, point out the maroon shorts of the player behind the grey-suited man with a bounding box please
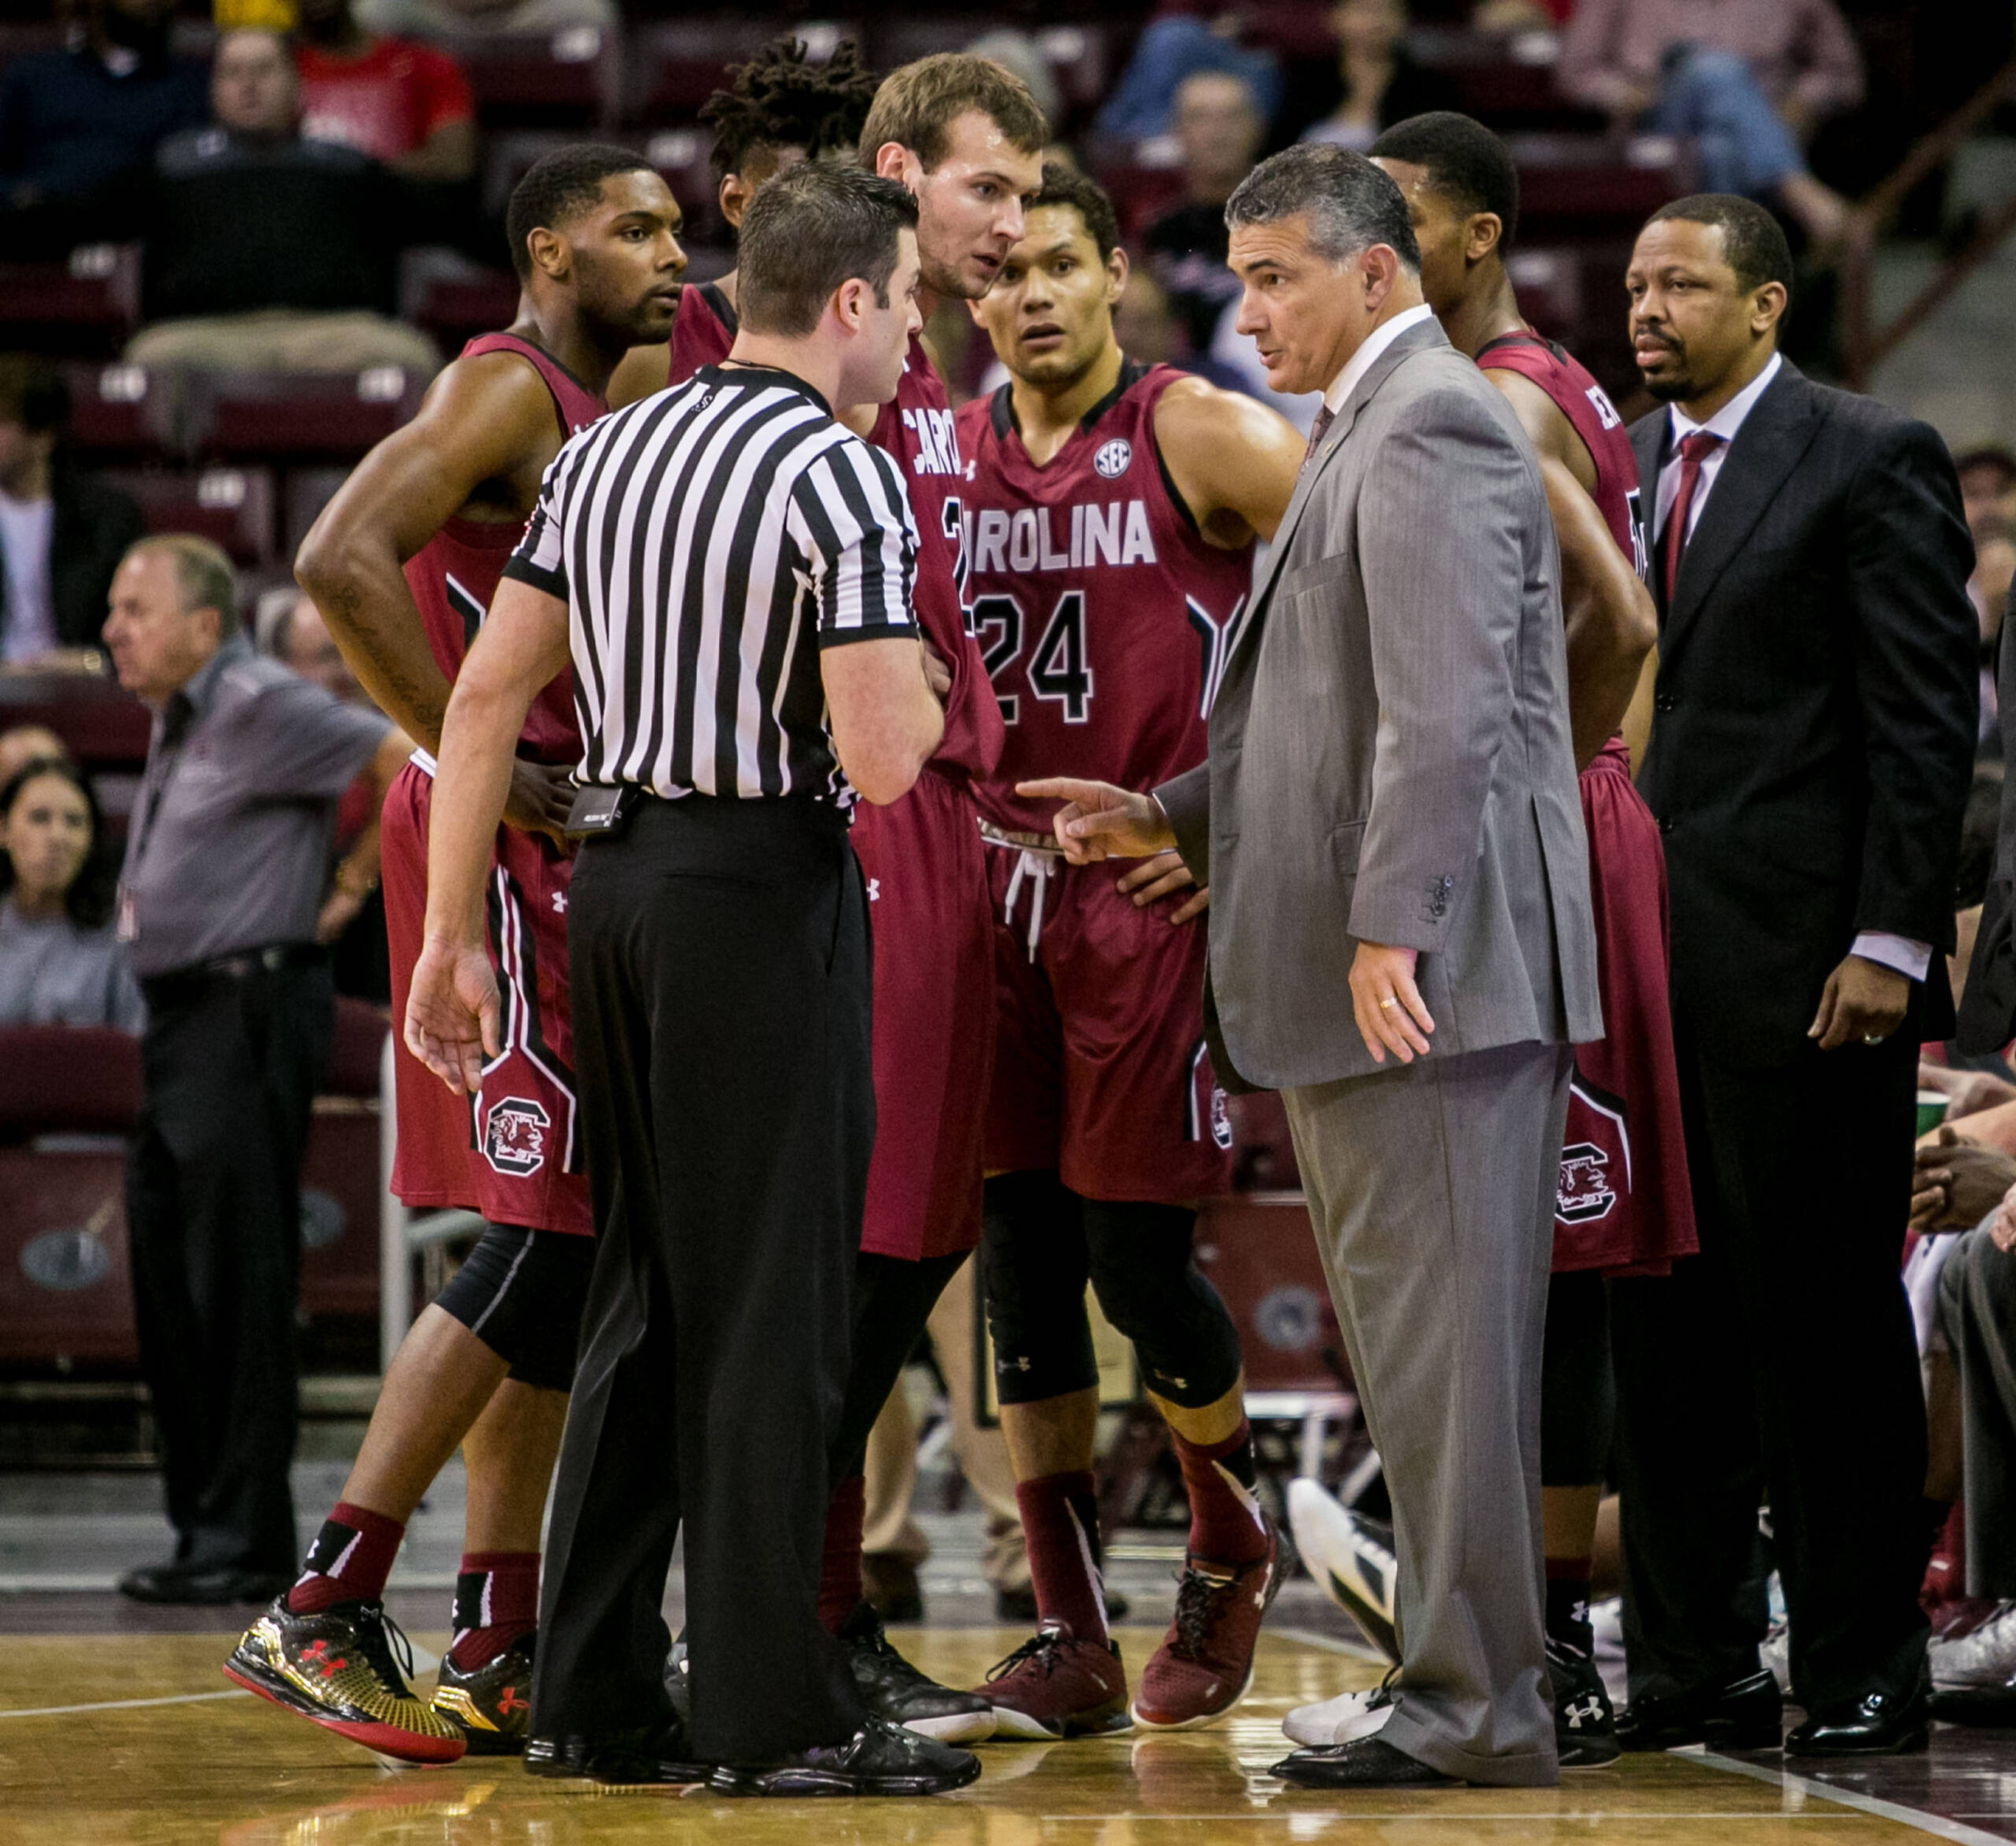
[1555,742,1697,1276]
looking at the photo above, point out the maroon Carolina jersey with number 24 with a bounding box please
[960,361,1254,834]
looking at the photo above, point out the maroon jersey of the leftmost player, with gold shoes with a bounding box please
[405,332,608,761]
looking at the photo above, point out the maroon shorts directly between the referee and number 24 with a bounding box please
[853,770,994,1261]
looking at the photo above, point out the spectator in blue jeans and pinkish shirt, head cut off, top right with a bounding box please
[1559,0,1863,248]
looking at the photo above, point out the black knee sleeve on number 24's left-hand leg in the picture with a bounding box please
[979,1173,1099,1405]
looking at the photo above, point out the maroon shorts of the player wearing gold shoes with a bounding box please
[379,761,595,1233]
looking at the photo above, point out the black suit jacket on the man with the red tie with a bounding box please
[1631,362,1980,1064]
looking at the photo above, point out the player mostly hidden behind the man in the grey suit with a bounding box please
[1288,111,1696,1767]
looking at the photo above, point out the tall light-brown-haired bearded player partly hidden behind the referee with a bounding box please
[619,52,1050,1743]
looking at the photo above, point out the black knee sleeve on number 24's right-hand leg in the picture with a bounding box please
[1084,1199,1240,1411]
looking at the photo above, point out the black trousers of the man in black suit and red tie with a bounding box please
[1611,1020,1931,1711]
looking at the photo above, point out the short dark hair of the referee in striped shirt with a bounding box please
[736,162,917,338]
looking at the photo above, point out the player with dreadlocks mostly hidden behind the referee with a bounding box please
[608,32,881,409]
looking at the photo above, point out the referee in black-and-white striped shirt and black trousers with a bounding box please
[405,165,979,1796]
